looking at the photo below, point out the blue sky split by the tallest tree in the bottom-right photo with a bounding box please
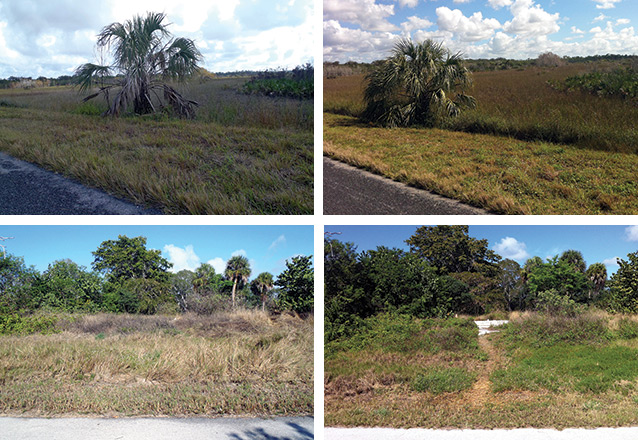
[324,225,638,274]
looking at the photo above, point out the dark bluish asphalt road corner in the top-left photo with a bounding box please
[0,152,162,215]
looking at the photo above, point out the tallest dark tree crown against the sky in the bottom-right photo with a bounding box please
[405,225,501,277]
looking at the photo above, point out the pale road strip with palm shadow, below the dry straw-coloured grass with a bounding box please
[0,417,314,440]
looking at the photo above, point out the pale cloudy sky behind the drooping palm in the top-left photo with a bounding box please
[0,0,314,78]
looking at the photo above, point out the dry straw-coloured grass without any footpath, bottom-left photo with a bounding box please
[0,311,313,416]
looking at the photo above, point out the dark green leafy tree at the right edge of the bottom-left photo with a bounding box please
[275,255,315,313]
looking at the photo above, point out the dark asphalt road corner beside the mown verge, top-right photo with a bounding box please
[323,157,489,215]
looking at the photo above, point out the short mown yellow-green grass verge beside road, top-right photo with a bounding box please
[324,113,638,214]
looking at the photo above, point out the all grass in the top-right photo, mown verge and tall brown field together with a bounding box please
[324,64,638,214]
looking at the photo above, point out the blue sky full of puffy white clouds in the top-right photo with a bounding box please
[323,0,638,62]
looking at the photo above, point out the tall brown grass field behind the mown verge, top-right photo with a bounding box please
[324,63,638,152]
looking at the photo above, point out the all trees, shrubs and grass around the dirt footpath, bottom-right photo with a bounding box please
[324,226,638,429]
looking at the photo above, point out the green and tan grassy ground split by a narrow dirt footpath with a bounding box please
[325,312,638,429]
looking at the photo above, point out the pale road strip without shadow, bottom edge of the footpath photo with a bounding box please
[324,428,638,440]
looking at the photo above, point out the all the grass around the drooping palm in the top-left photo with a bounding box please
[0,78,313,214]
